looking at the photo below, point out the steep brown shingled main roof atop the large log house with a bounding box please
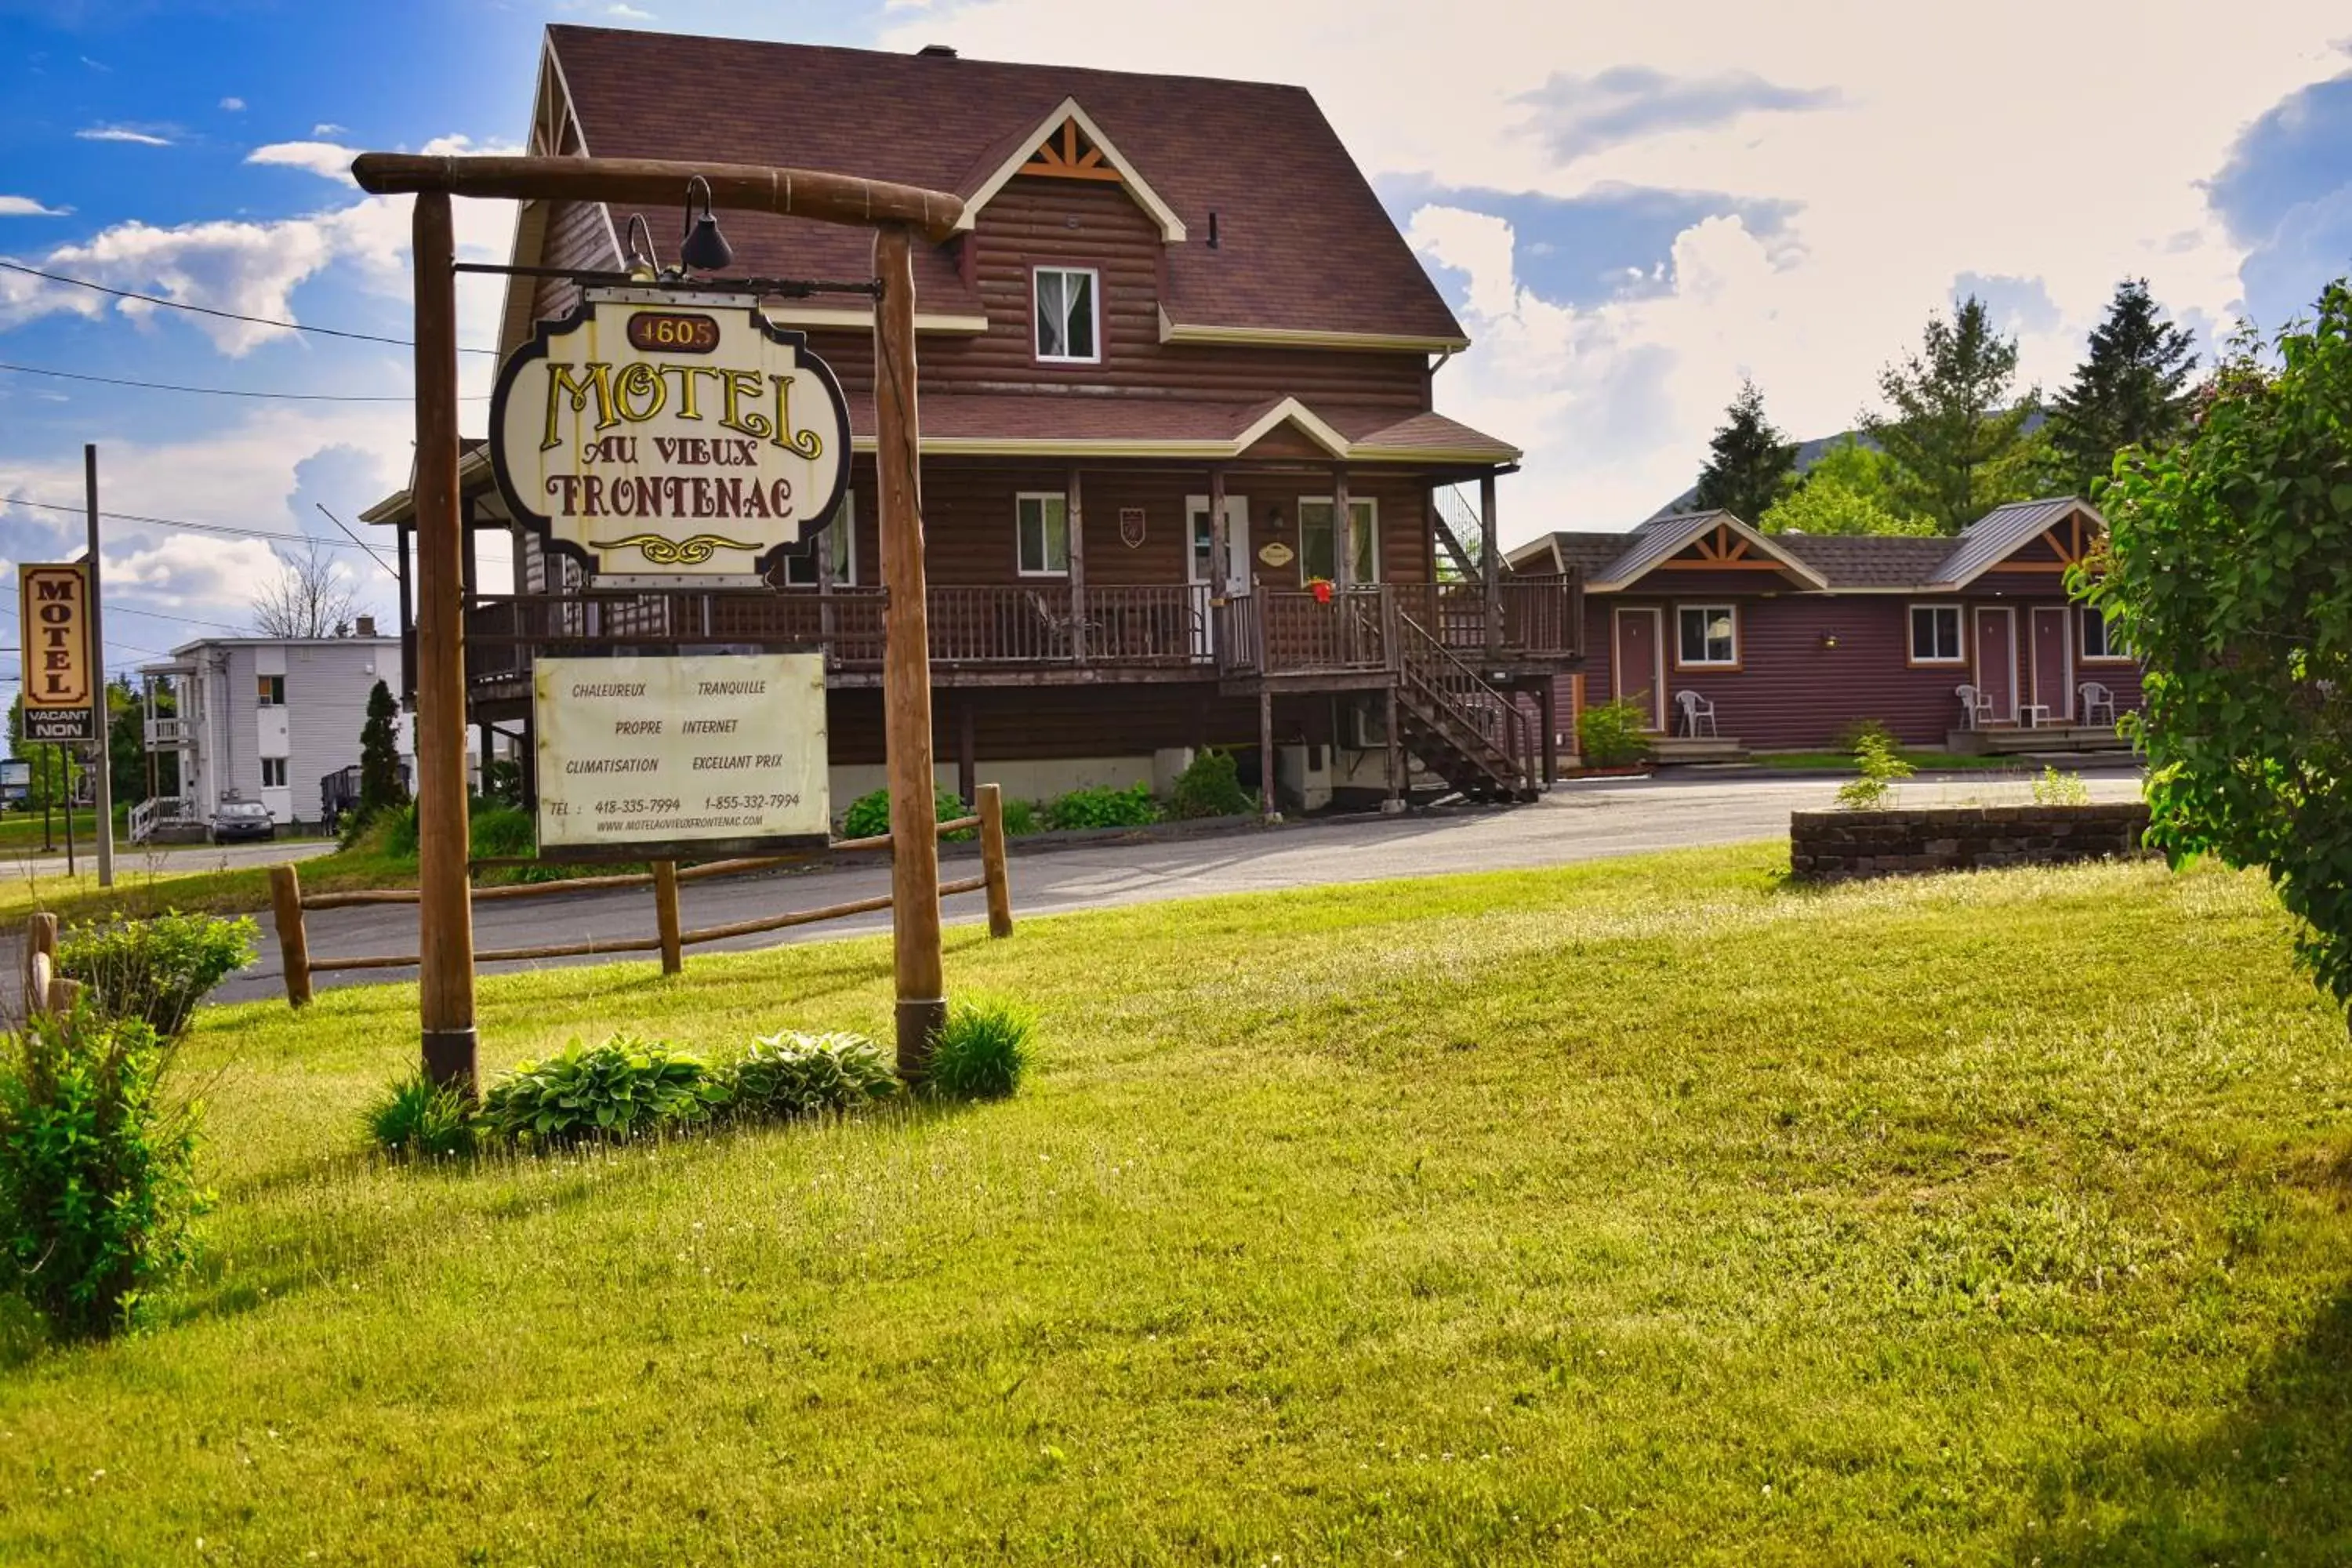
[548,26,1465,341]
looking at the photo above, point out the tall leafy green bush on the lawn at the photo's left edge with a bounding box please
[0,1001,205,1335]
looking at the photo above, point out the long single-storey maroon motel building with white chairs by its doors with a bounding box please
[1510,496,2140,757]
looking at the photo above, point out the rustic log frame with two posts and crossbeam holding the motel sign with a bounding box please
[350,153,964,1093]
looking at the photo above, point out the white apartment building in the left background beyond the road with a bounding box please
[132,616,412,839]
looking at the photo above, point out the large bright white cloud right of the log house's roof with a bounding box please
[882,0,2343,539]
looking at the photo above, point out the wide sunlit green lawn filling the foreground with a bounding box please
[0,846,2352,1568]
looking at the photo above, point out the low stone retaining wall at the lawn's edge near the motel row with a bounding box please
[1788,801,2147,881]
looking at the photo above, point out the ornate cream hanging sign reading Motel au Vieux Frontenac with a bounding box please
[489,289,849,588]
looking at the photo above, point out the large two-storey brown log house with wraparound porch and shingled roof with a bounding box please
[367,26,1583,806]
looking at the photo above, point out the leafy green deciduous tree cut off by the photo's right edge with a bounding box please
[2077,282,2352,1029]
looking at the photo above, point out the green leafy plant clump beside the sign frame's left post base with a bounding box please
[480,1034,724,1145]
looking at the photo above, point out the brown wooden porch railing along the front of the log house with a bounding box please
[466,579,1583,680]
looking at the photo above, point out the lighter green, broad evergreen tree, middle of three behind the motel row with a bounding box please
[1863,294,2042,534]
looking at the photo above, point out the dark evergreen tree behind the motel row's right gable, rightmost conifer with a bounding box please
[2051,278,2197,496]
